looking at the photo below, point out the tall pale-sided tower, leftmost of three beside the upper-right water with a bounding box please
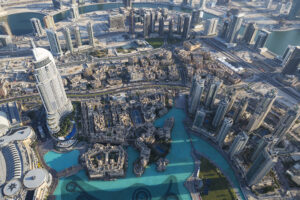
[225,14,243,43]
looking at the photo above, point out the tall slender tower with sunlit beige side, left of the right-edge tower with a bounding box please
[247,89,277,132]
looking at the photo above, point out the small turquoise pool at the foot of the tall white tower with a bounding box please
[44,150,80,172]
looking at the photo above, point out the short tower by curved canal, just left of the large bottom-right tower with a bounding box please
[228,131,249,159]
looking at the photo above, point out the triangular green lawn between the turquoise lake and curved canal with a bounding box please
[200,158,237,200]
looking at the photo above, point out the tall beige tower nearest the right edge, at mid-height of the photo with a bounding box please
[273,106,299,144]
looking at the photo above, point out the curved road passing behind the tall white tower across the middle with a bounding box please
[0,82,188,103]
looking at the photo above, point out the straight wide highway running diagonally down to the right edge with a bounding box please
[203,39,300,102]
